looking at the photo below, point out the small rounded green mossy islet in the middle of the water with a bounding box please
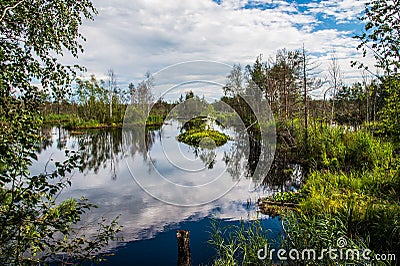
[177,129,231,147]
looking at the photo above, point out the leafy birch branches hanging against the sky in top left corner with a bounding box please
[0,0,97,98]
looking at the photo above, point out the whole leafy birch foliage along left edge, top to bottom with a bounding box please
[0,0,117,265]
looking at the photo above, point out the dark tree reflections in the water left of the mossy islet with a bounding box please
[38,127,158,180]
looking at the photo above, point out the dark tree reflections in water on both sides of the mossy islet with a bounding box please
[38,121,301,190]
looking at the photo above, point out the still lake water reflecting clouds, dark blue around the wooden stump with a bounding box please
[31,120,291,265]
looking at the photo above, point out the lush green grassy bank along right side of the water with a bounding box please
[213,124,400,265]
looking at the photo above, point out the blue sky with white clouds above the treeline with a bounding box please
[63,0,373,97]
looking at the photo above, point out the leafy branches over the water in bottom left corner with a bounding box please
[0,148,119,264]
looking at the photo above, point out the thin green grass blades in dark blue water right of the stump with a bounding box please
[208,220,272,266]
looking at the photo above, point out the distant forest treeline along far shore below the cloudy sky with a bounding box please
[41,48,397,141]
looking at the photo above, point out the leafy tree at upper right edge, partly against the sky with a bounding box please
[352,0,400,135]
